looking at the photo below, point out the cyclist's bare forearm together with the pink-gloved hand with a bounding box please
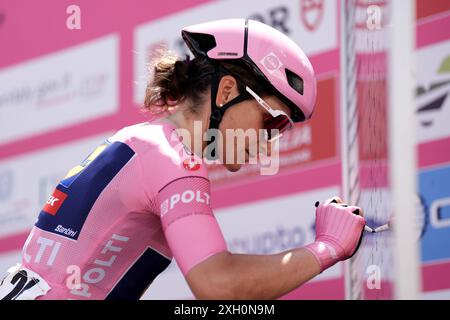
[186,198,365,299]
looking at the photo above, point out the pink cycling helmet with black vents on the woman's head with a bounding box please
[181,19,317,122]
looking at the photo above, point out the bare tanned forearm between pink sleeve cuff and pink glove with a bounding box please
[186,248,320,299]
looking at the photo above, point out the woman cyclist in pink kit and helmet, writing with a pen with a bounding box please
[0,19,365,299]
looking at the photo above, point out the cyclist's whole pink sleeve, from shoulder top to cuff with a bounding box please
[129,125,227,275]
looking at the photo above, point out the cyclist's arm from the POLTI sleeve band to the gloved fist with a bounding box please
[158,168,364,299]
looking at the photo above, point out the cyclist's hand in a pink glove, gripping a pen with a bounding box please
[305,197,366,272]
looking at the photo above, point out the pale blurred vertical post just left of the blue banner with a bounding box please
[388,0,421,299]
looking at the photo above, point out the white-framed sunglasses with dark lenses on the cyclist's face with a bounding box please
[245,86,294,142]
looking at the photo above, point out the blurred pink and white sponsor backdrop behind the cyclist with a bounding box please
[0,0,450,299]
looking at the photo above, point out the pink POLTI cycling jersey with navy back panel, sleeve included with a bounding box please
[18,122,227,299]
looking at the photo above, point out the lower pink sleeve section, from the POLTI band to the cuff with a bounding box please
[157,176,227,275]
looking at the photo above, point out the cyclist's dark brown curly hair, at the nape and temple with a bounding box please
[144,50,261,113]
